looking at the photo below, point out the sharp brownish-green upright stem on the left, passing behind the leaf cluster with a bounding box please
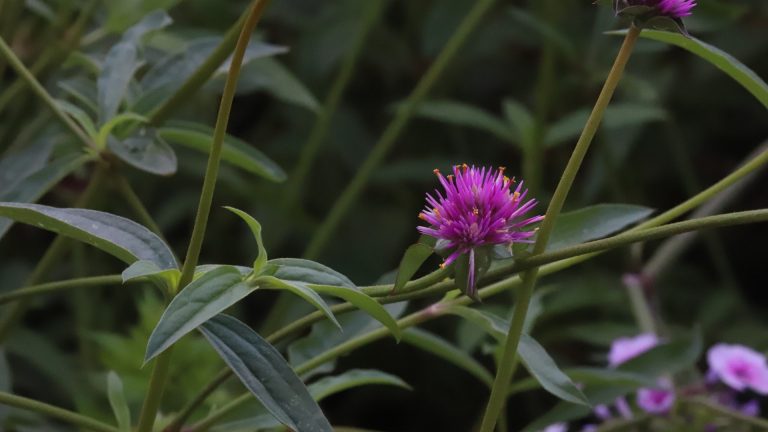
[137,4,269,432]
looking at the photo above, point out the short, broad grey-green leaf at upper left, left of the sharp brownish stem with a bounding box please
[107,127,178,176]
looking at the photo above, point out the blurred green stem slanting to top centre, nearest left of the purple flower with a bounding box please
[304,0,495,259]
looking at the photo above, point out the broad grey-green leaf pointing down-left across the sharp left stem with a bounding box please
[144,266,249,364]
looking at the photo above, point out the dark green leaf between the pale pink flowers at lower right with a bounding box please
[617,331,703,377]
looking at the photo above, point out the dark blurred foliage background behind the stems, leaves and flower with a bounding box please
[0,0,768,431]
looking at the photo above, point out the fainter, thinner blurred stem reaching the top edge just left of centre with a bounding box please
[285,0,385,209]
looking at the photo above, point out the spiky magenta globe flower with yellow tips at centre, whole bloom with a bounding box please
[418,164,543,296]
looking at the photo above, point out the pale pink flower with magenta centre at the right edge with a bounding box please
[707,344,768,395]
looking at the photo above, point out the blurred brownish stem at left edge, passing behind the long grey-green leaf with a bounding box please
[0,164,107,344]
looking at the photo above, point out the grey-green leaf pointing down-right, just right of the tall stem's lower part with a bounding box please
[517,333,589,406]
